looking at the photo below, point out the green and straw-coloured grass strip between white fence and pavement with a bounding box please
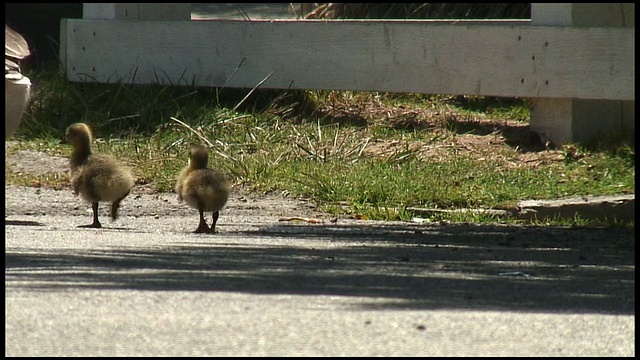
[6,61,635,226]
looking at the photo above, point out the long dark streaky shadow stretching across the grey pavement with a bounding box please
[5,224,635,315]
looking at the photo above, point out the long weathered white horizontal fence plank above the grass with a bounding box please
[61,20,635,100]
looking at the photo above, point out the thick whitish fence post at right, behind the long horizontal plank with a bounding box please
[530,3,635,146]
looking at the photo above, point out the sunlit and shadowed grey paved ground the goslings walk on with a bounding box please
[5,187,635,356]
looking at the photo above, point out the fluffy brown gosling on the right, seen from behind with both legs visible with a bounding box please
[175,145,231,234]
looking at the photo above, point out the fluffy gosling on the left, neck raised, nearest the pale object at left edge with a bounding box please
[65,123,135,228]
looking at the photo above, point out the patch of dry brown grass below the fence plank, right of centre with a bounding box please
[302,92,565,169]
